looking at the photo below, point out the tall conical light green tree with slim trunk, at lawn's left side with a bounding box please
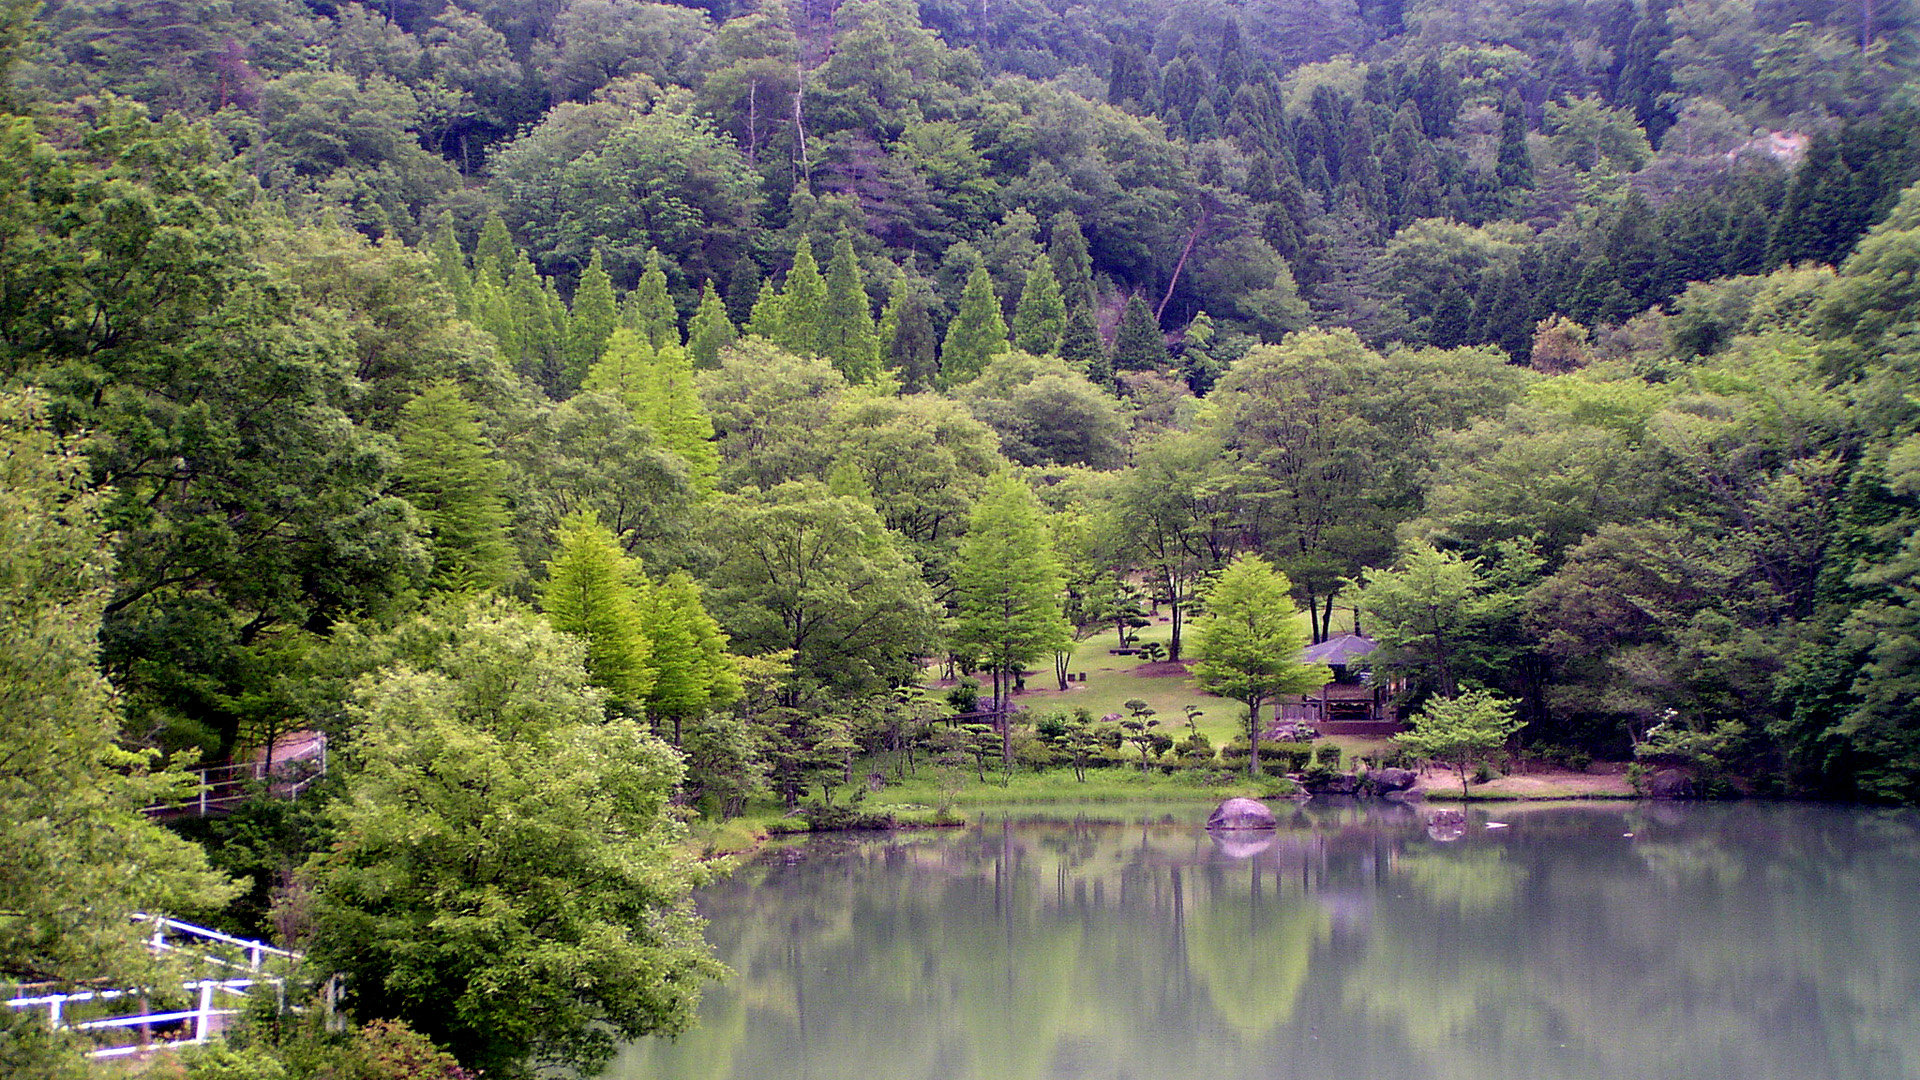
[954,475,1073,763]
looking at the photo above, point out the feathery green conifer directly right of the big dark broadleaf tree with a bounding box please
[394,379,515,592]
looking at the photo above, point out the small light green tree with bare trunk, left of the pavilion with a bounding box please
[1194,555,1332,776]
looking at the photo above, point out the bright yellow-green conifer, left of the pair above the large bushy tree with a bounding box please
[538,509,655,711]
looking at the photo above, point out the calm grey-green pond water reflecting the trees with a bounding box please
[611,803,1920,1080]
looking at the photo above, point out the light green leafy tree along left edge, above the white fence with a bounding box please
[0,394,236,984]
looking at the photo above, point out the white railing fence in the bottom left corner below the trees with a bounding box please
[6,915,318,1059]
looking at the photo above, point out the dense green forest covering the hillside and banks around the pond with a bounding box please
[11,0,1920,1074]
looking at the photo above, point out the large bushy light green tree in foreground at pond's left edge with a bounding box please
[303,591,724,1078]
